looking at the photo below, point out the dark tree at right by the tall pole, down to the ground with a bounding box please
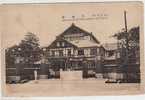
[113,26,140,82]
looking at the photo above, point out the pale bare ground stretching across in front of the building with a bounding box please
[5,79,140,96]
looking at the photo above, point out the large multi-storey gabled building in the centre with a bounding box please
[44,24,104,77]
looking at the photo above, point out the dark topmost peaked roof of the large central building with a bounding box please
[59,23,100,43]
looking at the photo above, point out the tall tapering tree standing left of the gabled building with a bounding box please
[19,32,41,64]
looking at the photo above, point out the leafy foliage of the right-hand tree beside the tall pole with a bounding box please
[113,26,139,64]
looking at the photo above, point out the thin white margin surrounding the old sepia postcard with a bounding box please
[0,0,145,100]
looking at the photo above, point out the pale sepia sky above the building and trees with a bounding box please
[0,2,143,48]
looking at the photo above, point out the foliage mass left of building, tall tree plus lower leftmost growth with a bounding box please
[6,32,41,64]
